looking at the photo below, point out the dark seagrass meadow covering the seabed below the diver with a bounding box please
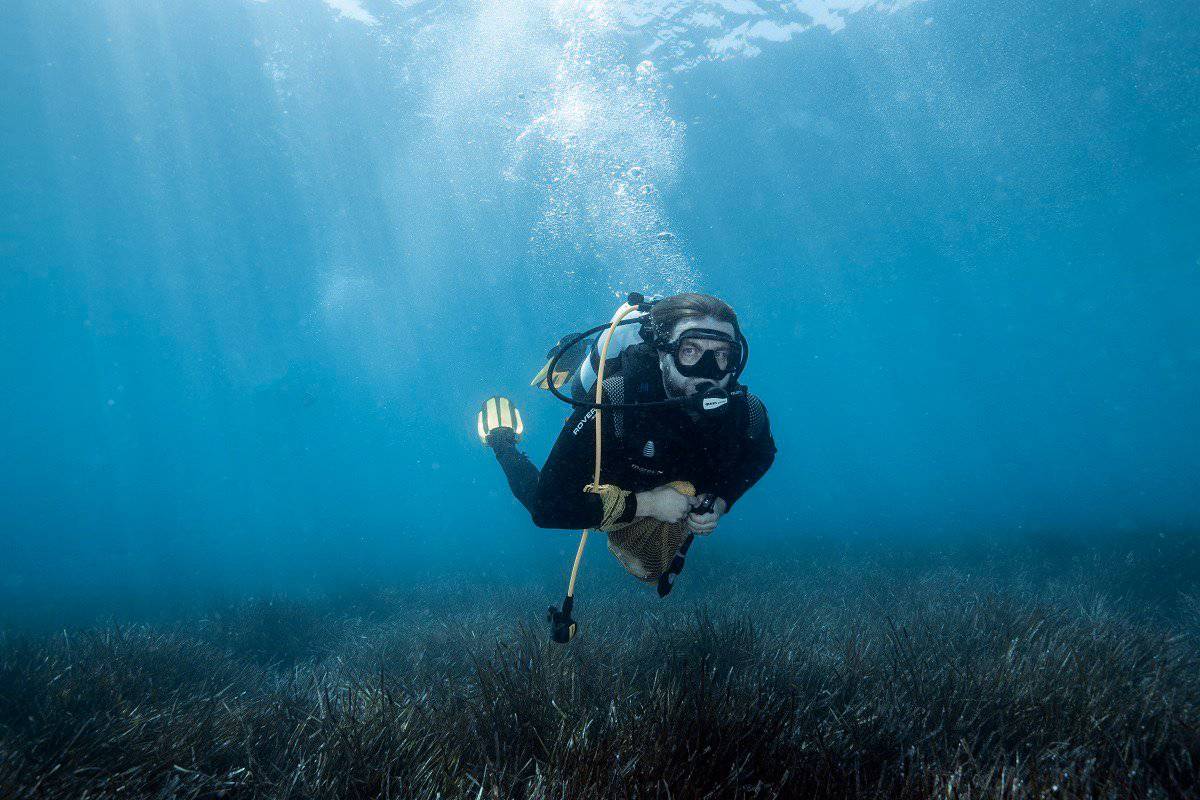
[0,533,1200,800]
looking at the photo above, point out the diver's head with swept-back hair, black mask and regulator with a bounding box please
[643,293,743,397]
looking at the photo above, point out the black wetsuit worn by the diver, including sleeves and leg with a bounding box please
[492,345,775,529]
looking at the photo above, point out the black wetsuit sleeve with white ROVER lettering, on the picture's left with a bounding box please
[532,409,637,529]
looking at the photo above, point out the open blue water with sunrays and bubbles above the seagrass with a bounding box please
[0,0,1200,615]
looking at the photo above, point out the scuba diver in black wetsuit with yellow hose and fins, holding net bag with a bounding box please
[478,293,775,642]
